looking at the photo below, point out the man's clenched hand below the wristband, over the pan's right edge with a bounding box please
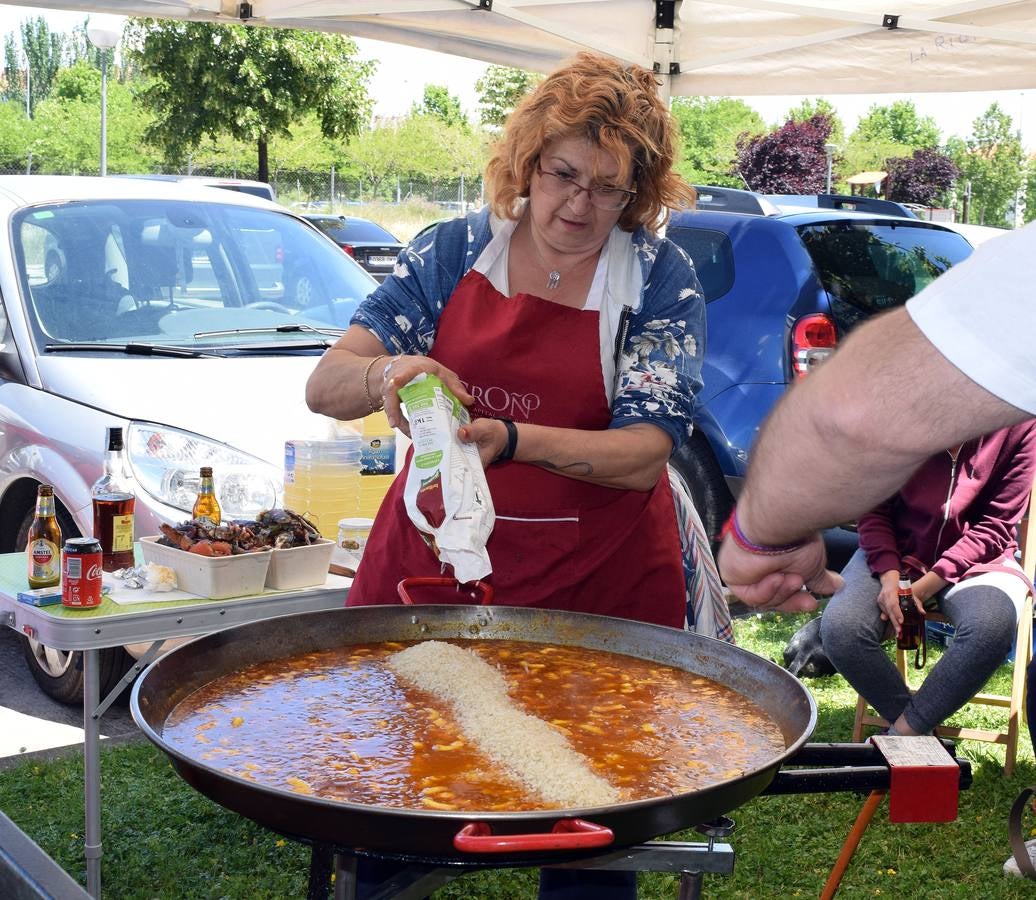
[716,526,843,612]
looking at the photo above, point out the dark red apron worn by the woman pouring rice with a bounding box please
[347,270,685,628]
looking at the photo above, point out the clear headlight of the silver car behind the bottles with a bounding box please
[126,422,282,519]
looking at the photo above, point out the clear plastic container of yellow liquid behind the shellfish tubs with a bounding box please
[284,434,362,541]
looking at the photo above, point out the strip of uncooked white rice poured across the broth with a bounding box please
[389,641,621,808]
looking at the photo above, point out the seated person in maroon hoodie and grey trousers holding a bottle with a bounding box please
[821,420,1036,734]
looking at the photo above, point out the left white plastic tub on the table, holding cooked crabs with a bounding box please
[140,534,272,600]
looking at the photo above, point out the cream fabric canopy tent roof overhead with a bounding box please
[8,0,1036,95]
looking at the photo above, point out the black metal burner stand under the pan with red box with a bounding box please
[307,736,972,900]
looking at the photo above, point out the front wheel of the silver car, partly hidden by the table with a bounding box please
[15,495,133,705]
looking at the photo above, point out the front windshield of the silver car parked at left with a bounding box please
[11,200,377,346]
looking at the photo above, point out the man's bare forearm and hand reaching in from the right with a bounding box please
[718,309,1031,610]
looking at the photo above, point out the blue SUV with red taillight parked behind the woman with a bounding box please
[666,187,972,539]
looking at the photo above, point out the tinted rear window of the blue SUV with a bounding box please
[799,220,971,330]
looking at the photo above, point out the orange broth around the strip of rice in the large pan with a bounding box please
[163,640,785,811]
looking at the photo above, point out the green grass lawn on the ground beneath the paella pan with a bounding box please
[0,614,1036,900]
